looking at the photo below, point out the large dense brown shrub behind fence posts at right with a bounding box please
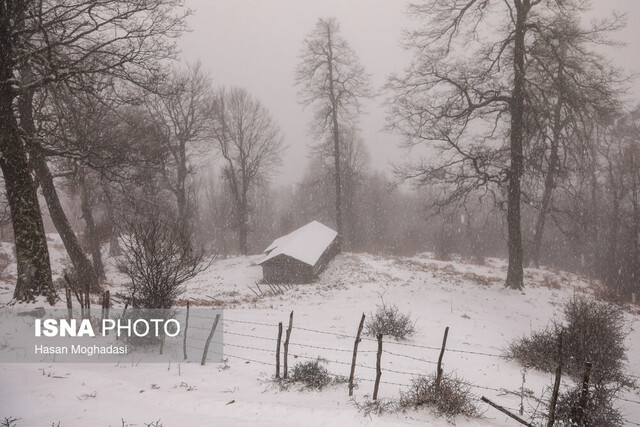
[507,297,635,386]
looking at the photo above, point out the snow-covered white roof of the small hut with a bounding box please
[258,221,338,266]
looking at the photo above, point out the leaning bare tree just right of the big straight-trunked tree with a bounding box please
[525,16,623,267]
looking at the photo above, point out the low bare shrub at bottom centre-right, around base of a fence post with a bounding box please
[399,374,481,420]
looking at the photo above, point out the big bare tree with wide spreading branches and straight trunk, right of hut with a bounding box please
[388,0,618,288]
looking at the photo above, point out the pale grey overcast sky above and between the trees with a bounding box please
[180,0,640,183]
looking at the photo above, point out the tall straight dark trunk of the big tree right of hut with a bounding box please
[505,0,530,289]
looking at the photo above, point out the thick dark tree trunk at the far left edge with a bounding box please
[0,9,56,303]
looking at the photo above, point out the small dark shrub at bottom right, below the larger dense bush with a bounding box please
[556,384,624,427]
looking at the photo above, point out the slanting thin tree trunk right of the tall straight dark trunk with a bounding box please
[531,63,563,268]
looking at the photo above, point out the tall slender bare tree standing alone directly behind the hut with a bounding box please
[296,18,371,241]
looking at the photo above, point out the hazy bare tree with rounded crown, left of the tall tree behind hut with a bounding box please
[212,88,284,255]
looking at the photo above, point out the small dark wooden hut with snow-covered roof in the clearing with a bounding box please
[258,221,340,283]
